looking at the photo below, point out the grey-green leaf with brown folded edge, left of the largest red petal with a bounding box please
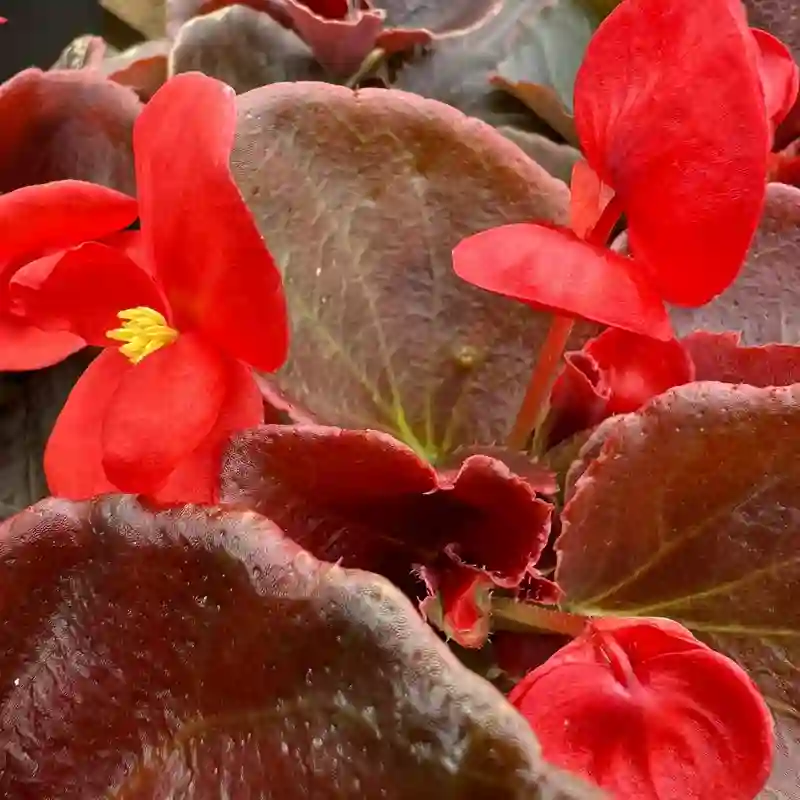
[492,0,596,144]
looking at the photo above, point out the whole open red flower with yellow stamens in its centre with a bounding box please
[12,73,288,502]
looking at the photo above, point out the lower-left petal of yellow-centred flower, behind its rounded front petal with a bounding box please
[44,352,133,500]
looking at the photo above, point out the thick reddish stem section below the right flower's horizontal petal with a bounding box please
[506,314,575,450]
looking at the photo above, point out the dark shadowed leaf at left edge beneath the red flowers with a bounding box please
[0,351,93,519]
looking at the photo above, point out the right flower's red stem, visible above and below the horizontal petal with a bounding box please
[506,195,622,450]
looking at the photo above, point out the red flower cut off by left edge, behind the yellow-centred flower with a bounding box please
[0,180,136,371]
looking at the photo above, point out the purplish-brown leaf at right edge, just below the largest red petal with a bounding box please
[670,183,800,345]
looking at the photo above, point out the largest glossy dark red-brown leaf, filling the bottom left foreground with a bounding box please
[0,496,592,800]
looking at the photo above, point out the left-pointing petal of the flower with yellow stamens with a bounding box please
[9,242,168,347]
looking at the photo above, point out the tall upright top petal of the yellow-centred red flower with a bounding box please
[134,73,288,371]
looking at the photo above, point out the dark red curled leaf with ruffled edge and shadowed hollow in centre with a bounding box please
[220,425,551,644]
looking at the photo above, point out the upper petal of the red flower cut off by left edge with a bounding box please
[0,181,137,278]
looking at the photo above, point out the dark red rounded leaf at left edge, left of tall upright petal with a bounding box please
[0,69,141,194]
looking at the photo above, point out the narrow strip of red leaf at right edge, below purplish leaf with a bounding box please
[681,331,800,387]
